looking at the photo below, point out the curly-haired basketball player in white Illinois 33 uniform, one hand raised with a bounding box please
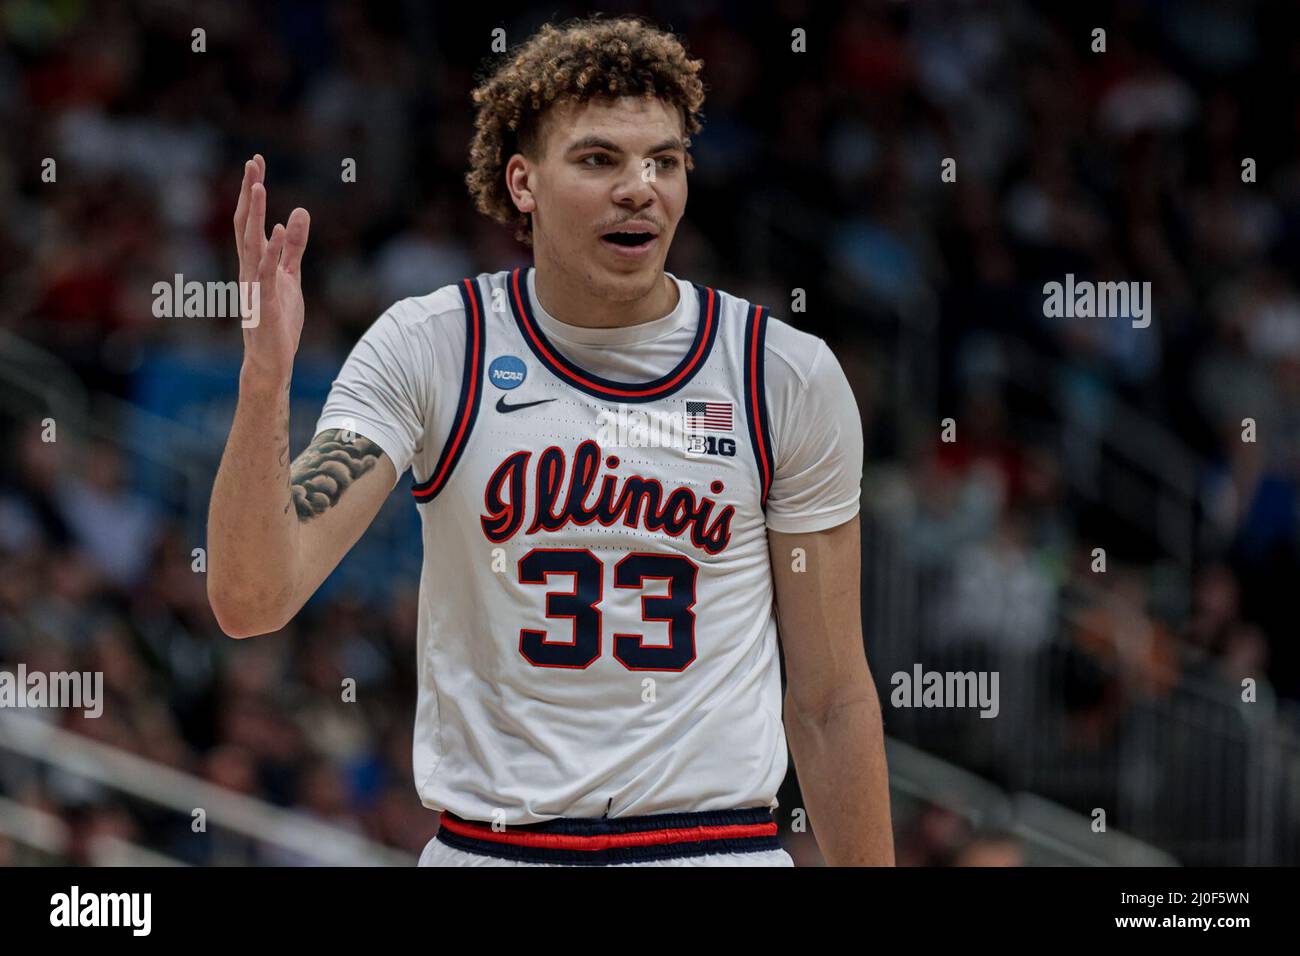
[208,20,893,866]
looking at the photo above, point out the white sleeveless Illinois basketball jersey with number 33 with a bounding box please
[412,269,787,825]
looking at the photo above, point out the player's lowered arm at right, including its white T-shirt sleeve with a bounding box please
[766,335,894,865]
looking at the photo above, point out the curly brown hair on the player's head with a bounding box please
[465,17,705,245]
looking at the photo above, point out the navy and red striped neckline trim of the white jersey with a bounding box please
[510,267,718,402]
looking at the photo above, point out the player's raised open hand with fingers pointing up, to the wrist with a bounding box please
[235,155,311,382]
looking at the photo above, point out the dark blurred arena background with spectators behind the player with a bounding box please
[0,0,1300,888]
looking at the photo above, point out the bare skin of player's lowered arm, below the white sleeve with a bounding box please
[768,516,894,866]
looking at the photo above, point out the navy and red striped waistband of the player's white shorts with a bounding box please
[438,806,781,866]
